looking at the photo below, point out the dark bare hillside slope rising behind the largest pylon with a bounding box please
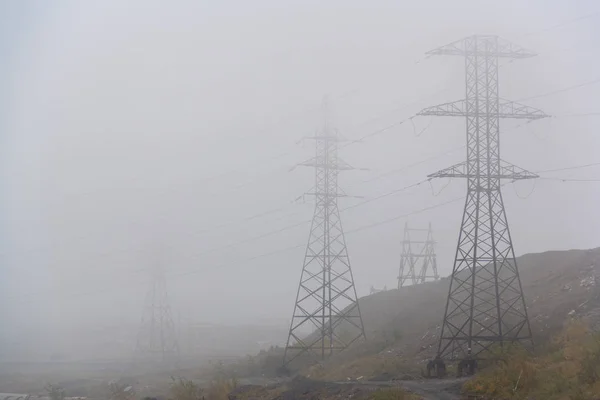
[288,248,600,380]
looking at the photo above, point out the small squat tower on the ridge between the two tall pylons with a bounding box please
[398,222,440,289]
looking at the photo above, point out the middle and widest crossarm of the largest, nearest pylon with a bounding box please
[417,99,549,120]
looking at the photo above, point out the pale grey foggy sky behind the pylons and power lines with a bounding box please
[0,0,600,344]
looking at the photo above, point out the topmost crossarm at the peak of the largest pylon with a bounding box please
[426,35,536,58]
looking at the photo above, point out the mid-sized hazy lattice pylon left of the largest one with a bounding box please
[283,101,366,366]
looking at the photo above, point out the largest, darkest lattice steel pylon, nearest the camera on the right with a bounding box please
[419,35,548,360]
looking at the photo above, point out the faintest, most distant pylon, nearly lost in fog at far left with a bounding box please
[134,253,180,363]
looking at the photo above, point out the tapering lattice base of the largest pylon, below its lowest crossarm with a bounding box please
[438,188,532,359]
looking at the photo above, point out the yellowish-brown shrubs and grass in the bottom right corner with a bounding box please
[463,320,600,400]
